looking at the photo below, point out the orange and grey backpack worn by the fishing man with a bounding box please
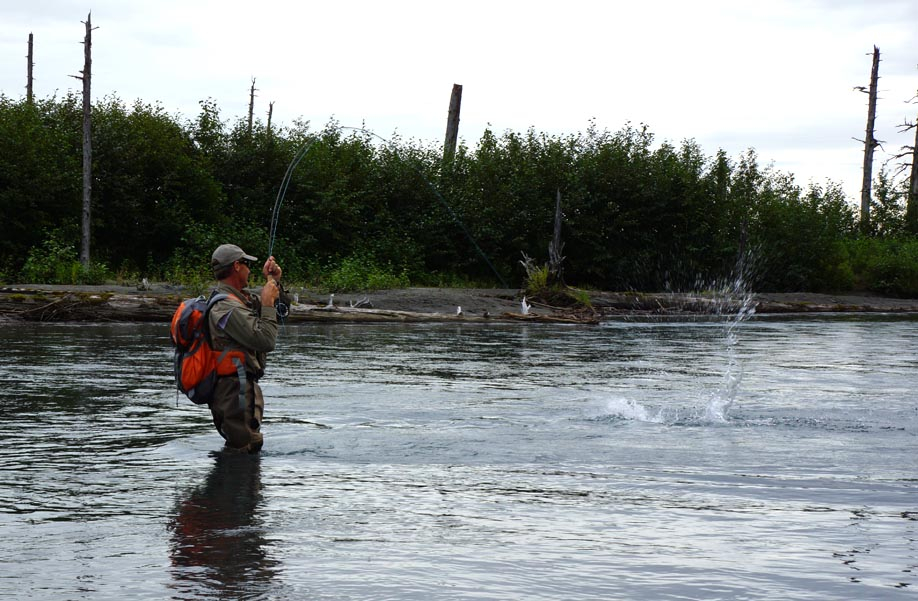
[169,291,245,405]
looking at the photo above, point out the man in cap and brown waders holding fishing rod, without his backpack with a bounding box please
[207,244,286,453]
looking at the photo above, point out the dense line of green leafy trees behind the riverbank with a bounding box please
[0,94,918,296]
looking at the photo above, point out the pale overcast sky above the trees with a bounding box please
[0,0,918,200]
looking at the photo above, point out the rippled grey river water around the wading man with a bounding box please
[0,316,918,600]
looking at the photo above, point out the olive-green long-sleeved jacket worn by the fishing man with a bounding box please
[208,282,277,380]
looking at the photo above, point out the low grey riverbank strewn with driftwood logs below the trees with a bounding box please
[0,284,918,323]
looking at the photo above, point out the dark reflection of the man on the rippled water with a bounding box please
[170,453,277,598]
